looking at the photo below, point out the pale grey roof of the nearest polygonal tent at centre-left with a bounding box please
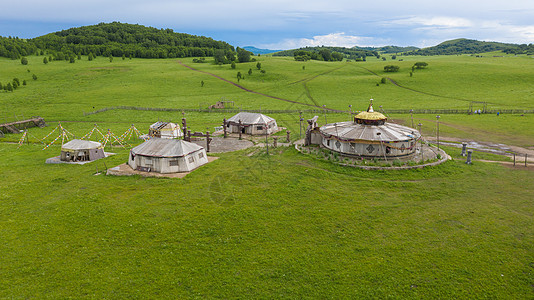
[131,138,203,157]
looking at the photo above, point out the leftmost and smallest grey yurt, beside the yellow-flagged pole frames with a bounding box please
[60,139,106,162]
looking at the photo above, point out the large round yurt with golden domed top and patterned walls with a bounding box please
[319,100,421,158]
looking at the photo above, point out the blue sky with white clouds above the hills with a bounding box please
[0,0,534,49]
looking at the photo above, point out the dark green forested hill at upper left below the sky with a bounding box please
[0,22,234,59]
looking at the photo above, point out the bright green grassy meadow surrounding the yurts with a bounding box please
[0,54,534,299]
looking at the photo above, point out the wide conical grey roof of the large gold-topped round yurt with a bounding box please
[320,122,421,142]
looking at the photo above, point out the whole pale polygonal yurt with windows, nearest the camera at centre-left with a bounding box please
[128,138,208,173]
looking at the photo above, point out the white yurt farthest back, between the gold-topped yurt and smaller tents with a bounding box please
[226,112,278,135]
